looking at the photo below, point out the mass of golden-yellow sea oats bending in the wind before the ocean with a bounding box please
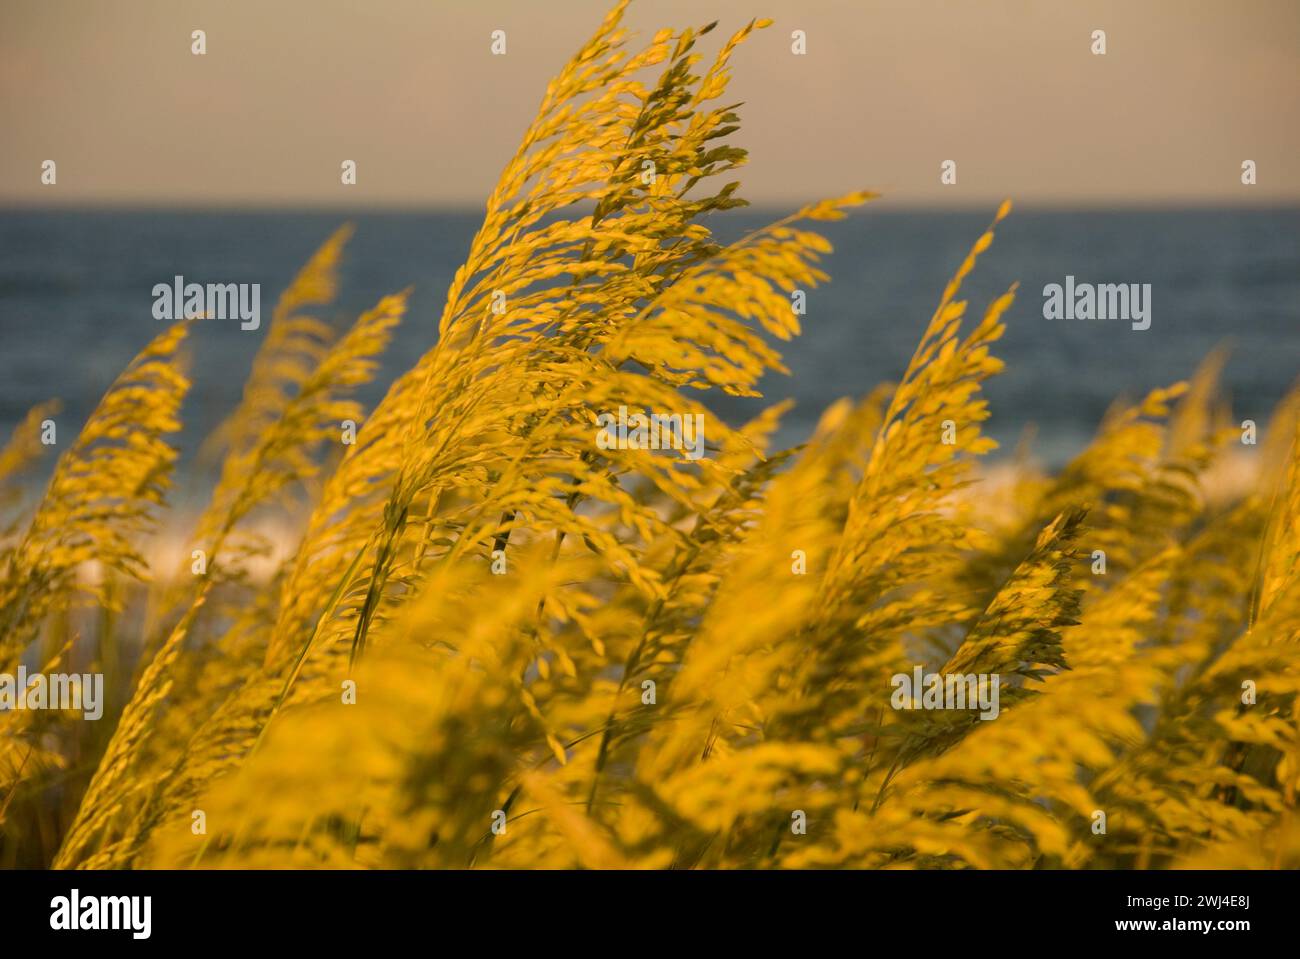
[0,3,1300,869]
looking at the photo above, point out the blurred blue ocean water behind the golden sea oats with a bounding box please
[0,207,1300,473]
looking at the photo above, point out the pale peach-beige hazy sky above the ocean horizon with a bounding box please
[0,0,1300,208]
